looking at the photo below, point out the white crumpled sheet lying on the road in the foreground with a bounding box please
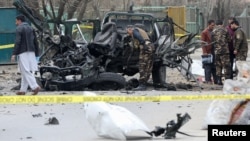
[84,91,150,141]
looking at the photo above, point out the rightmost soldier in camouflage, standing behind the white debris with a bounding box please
[231,20,248,61]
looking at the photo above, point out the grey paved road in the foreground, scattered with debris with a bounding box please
[0,91,221,141]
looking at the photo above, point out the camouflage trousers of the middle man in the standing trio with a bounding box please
[215,53,232,79]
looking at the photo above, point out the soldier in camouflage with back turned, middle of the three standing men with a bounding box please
[212,20,231,85]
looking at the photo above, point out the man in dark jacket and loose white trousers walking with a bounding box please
[11,15,40,95]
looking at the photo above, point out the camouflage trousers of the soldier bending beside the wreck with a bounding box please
[139,44,154,84]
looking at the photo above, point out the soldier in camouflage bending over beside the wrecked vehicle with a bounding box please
[127,25,154,91]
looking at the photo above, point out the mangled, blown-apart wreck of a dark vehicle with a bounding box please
[14,0,208,90]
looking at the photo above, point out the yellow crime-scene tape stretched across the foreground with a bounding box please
[0,94,250,104]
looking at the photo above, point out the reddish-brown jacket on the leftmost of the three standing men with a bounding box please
[201,28,212,54]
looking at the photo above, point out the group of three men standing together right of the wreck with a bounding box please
[201,17,248,85]
